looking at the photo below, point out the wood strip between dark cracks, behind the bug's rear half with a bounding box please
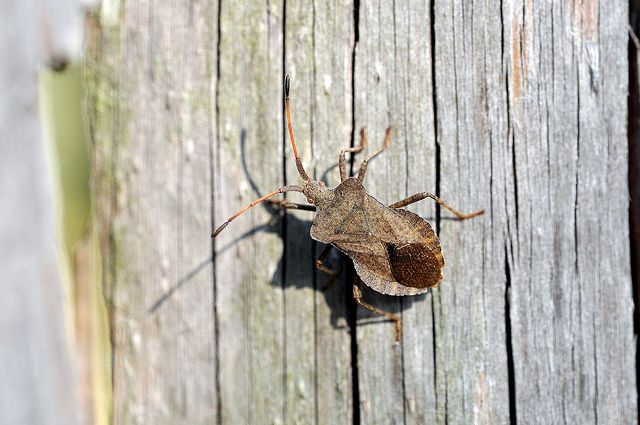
[355,2,446,423]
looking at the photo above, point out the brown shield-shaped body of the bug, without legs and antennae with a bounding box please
[311,178,444,295]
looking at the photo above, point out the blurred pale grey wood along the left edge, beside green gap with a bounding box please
[0,0,85,424]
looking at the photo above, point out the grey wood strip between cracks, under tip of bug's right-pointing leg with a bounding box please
[434,2,509,423]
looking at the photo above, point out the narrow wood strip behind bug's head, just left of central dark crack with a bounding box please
[304,0,354,425]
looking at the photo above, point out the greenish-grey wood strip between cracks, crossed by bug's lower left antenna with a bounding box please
[214,2,285,423]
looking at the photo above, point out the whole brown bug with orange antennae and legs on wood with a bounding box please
[211,75,484,341]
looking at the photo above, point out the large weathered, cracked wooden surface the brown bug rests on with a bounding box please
[88,1,637,424]
